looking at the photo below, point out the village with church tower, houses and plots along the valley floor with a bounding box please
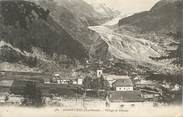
[0,70,180,107]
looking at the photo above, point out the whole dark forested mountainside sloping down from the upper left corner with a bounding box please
[0,0,88,60]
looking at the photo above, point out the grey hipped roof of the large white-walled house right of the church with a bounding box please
[112,79,133,87]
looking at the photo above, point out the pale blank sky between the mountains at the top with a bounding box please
[85,0,159,13]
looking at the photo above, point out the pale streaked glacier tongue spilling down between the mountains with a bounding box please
[89,26,160,63]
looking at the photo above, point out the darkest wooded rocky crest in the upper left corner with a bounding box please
[0,0,49,29]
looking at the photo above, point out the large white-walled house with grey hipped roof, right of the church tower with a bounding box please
[112,76,133,91]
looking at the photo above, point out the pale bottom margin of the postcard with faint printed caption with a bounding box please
[0,105,182,117]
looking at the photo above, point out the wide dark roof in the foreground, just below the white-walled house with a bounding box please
[110,91,144,102]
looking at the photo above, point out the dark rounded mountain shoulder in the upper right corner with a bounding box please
[119,0,183,33]
